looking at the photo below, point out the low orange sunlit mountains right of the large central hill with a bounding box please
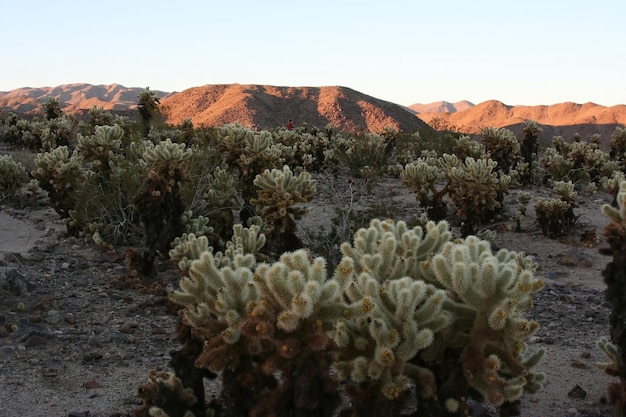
[418,100,626,143]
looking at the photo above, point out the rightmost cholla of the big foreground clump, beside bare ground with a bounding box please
[424,236,544,406]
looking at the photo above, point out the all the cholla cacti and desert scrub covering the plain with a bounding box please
[0,98,626,417]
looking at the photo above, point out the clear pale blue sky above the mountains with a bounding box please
[0,0,626,106]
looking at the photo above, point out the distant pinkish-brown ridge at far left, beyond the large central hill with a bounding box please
[0,83,168,114]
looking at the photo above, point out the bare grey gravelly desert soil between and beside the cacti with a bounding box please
[0,177,612,417]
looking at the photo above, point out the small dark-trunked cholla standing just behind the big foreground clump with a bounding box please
[250,165,316,252]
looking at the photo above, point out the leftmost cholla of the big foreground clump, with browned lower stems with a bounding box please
[172,250,343,416]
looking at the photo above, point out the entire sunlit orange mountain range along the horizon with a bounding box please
[0,83,626,139]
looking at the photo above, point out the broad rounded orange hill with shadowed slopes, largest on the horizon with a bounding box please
[161,84,425,132]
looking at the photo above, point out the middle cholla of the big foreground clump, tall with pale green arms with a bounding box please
[333,219,452,415]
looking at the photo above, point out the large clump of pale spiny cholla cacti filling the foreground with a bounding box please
[160,219,543,416]
